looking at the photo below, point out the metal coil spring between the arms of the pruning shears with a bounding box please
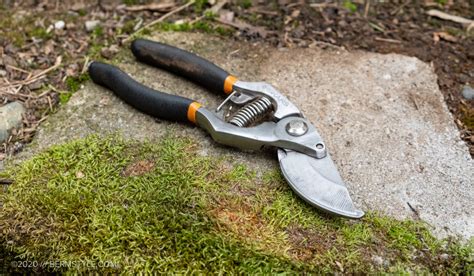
[229,97,272,127]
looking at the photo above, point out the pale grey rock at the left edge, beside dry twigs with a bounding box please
[0,102,25,143]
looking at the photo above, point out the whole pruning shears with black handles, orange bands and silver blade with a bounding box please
[89,39,364,218]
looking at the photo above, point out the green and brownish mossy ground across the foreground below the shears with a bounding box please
[0,135,473,273]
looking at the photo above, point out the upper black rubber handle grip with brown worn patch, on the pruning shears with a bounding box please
[131,39,232,93]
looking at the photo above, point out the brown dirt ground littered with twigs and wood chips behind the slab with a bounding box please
[0,0,474,159]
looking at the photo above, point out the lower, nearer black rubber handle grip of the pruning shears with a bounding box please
[89,61,193,122]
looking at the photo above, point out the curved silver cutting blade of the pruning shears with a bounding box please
[278,149,364,218]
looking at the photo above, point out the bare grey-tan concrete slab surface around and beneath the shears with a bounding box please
[15,33,474,238]
